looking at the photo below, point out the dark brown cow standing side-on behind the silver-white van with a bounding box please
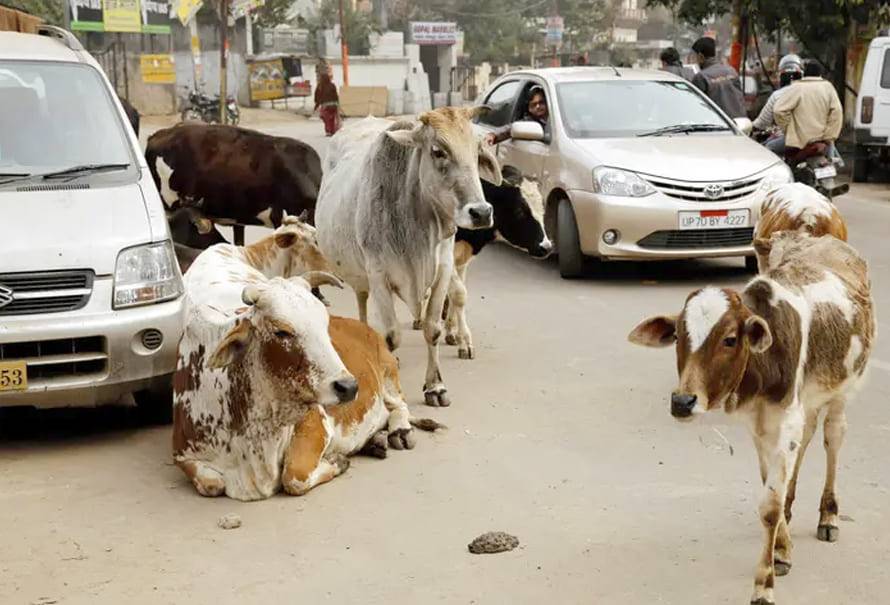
[145,124,321,244]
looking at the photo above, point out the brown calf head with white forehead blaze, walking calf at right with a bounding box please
[628,287,773,419]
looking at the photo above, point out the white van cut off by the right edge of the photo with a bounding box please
[853,31,890,182]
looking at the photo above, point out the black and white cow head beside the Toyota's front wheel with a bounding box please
[483,166,553,258]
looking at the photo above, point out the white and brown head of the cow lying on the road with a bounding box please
[209,272,358,410]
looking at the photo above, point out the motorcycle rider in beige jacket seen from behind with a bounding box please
[773,60,844,161]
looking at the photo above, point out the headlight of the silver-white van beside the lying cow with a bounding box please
[114,240,182,309]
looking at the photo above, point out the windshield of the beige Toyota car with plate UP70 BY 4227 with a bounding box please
[556,80,733,139]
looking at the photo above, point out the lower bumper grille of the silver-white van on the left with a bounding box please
[0,336,108,387]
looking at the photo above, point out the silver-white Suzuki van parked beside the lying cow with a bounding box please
[0,27,184,419]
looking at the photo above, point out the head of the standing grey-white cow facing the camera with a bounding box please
[386,106,501,229]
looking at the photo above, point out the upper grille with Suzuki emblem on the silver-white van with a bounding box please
[0,270,94,315]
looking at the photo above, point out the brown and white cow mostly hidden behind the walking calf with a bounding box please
[754,183,847,268]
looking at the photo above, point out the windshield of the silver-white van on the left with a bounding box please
[0,61,133,179]
